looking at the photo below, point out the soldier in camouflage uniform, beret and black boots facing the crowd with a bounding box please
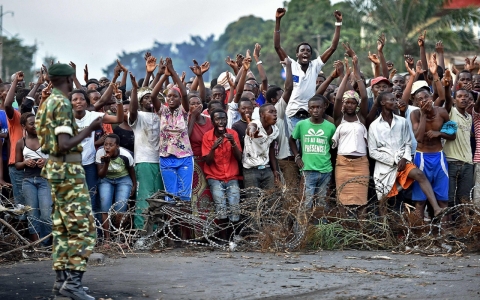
[35,64,101,299]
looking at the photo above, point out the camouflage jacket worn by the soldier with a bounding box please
[35,88,85,180]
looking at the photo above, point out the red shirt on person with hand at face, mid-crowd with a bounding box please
[202,128,242,182]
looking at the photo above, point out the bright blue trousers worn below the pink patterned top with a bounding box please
[159,155,193,201]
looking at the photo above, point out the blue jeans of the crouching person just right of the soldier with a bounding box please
[98,175,133,213]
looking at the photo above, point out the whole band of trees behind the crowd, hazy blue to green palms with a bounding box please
[99,0,480,86]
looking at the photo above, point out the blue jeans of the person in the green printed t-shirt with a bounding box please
[303,171,332,208]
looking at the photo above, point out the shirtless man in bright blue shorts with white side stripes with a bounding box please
[410,57,456,219]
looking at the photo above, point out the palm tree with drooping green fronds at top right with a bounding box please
[348,0,480,74]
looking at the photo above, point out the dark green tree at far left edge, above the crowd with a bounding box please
[0,35,37,81]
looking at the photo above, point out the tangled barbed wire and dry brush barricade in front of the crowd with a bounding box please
[0,173,480,262]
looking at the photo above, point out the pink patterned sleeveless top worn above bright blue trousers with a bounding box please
[158,105,193,158]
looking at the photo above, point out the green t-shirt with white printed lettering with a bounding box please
[292,119,335,173]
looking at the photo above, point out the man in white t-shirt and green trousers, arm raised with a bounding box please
[128,75,163,229]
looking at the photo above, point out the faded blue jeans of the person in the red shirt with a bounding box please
[208,178,240,222]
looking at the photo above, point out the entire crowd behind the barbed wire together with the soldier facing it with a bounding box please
[0,8,480,299]
